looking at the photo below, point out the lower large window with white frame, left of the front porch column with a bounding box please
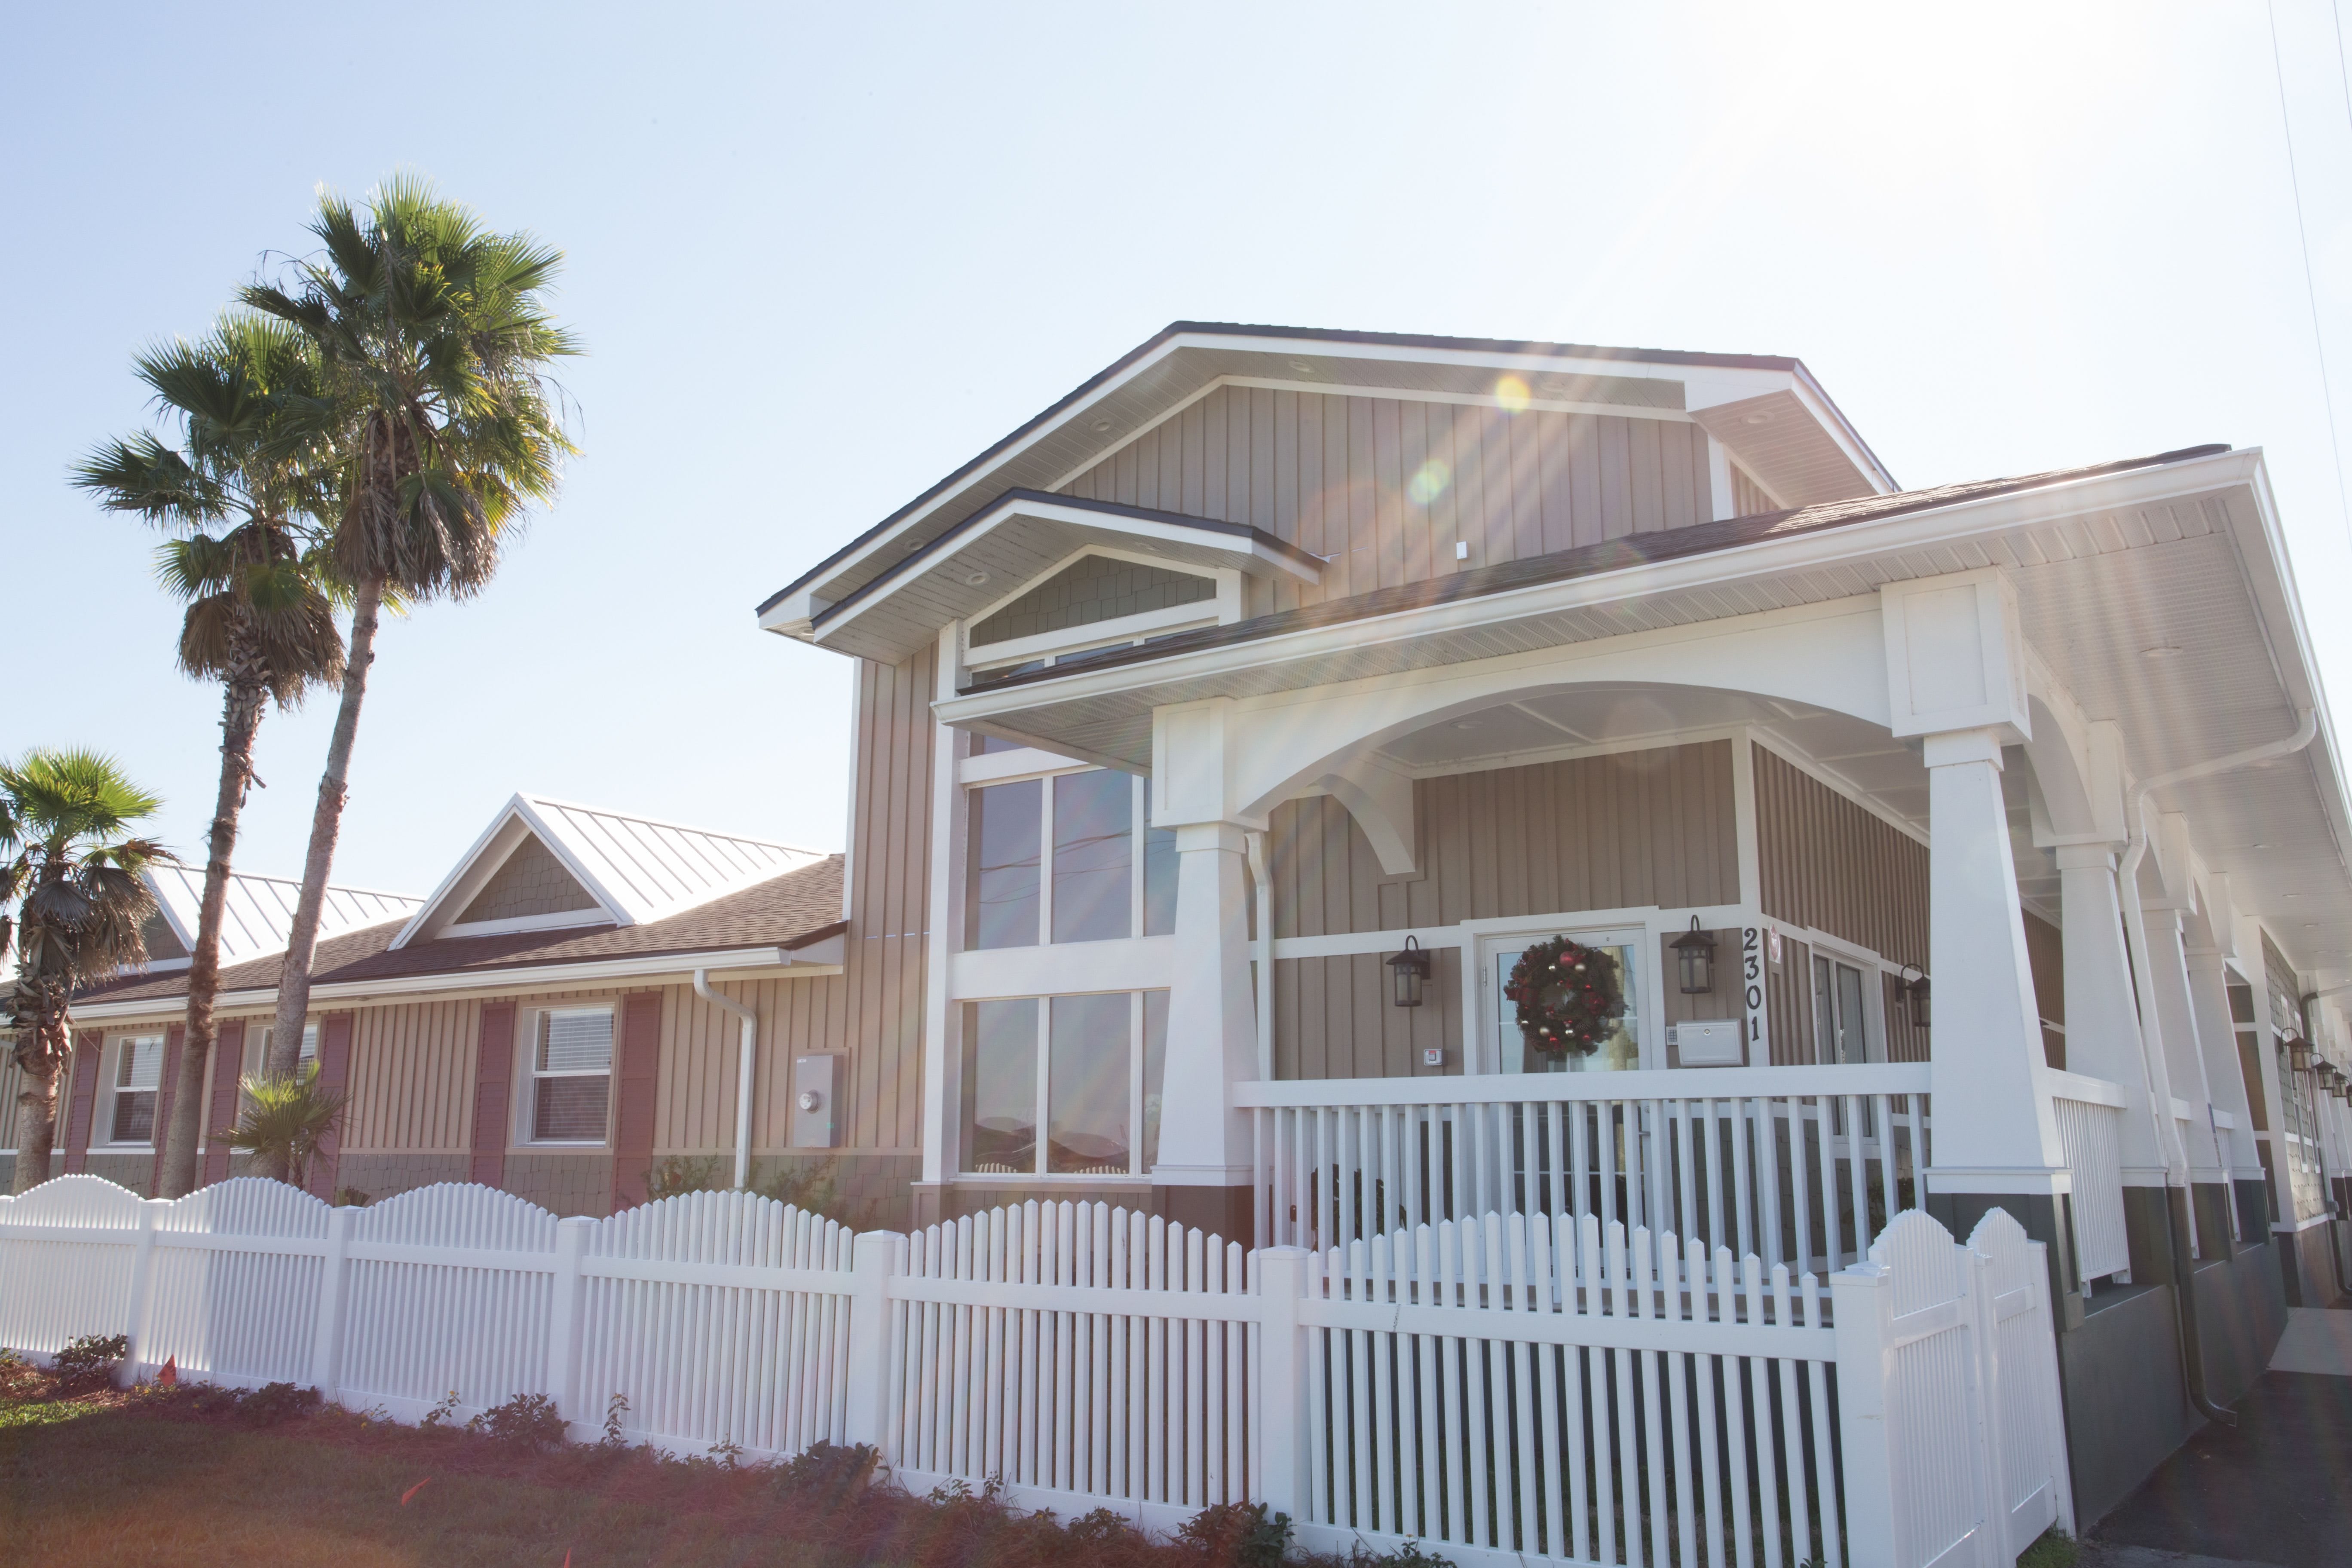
[962,992,1167,1176]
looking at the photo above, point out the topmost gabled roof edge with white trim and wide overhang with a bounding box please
[760,322,1896,637]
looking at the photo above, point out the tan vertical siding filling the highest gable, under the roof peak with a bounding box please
[1063,386,1715,616]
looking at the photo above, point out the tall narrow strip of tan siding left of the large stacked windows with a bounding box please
[840,649,938,1149]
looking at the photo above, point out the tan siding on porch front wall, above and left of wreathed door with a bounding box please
[1268,741,1740,1079]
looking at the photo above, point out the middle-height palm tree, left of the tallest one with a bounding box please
[73,315,343,1199]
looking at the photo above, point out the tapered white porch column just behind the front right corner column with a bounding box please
[2058,844,2164,1187]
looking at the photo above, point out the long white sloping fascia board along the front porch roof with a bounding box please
[936,451,2260,724]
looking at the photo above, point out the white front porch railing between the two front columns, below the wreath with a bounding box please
[1232,1063,1931,1272]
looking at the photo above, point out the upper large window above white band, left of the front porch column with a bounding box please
[965,769,1176,950]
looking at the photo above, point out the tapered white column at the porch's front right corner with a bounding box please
[1926,729,2072,1194]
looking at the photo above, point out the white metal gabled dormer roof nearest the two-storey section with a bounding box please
[390,795,823,947]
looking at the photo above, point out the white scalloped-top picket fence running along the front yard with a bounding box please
[0,1176,2072,1568]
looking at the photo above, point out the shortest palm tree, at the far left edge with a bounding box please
[0,750,172,1192]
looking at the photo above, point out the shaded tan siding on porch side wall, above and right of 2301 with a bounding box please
[1752,747,1926,964]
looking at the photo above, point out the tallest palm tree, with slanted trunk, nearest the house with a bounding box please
[242,176,579,1077]
